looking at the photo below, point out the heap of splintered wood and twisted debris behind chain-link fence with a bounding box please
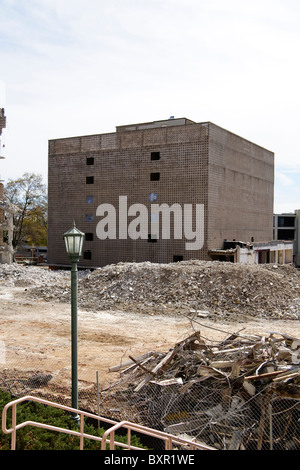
[101,332,300,450]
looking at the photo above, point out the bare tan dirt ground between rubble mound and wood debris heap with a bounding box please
[0,286,300,387]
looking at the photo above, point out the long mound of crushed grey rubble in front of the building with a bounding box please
[0,260,300,320]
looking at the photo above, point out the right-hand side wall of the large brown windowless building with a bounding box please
[208,124,274,249]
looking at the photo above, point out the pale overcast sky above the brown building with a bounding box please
[0,0,300,212]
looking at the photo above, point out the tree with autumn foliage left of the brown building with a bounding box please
[4,173,47,248]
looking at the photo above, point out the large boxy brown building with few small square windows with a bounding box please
[48,118,274,267]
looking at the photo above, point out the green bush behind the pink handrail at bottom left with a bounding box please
[0,390,148,450]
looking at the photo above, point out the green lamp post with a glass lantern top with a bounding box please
[64,222,84,421]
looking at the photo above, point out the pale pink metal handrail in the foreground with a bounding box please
[2,396,216,450]
